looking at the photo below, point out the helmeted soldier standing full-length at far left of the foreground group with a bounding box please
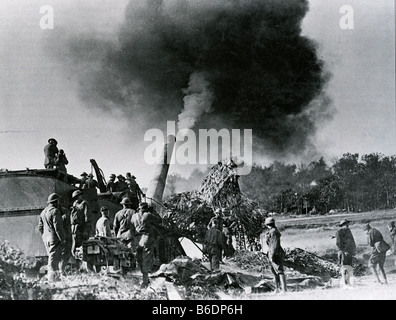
[38,193,65,282]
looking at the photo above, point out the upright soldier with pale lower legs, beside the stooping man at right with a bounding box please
[336,219,356,288]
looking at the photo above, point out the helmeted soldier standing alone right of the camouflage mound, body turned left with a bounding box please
[264,217,287,293]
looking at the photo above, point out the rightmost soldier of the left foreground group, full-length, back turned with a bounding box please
[132,202,160,288]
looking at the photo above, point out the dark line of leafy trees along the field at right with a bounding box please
[239,153,396,214]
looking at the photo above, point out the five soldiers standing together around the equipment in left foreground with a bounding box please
[38,189,161,286]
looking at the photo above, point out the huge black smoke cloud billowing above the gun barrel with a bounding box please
[51,0,331,155]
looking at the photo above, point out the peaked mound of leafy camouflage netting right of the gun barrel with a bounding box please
[164,161,266,242]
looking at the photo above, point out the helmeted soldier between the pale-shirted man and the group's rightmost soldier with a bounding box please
[114,198,135,248]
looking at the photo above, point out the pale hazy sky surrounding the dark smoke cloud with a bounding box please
[0,0,396,187]
